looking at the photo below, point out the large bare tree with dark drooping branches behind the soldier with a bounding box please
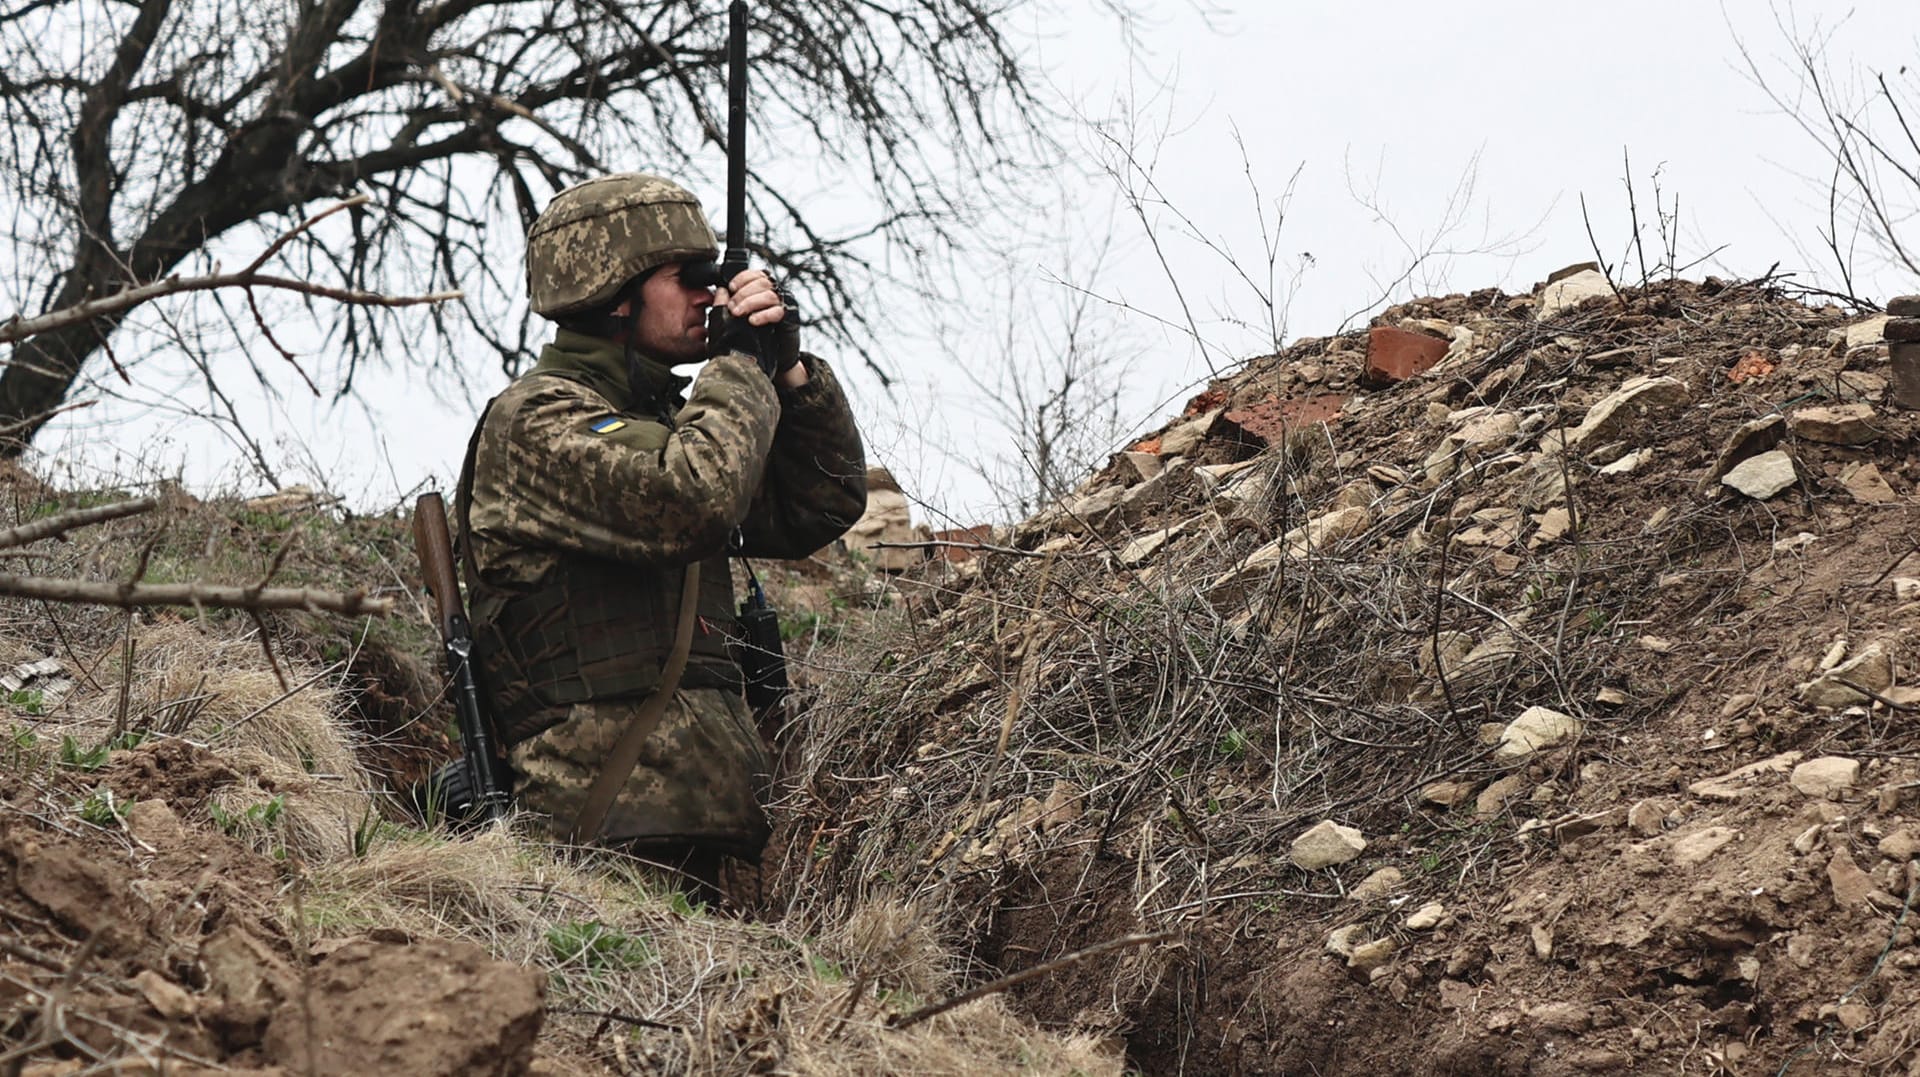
[0,0,1075,455]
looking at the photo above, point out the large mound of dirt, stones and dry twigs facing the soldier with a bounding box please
[783,275,1920,1073]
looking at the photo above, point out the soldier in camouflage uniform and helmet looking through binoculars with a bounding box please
[455,173,866,897]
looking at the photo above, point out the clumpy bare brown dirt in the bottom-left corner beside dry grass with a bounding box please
[0,741,545,1077]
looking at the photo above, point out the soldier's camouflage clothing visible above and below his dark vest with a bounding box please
[461,330,866,854]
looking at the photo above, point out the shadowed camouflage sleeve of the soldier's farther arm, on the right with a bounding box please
[741,355,866,559]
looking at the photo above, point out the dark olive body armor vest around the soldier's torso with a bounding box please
[455,371,741,745]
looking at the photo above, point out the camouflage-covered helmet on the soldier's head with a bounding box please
[526,173,720,319]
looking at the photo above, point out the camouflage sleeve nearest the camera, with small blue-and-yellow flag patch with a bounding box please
[472,355,781,564]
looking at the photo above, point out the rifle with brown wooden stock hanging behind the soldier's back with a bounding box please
[413,493,513,822]
